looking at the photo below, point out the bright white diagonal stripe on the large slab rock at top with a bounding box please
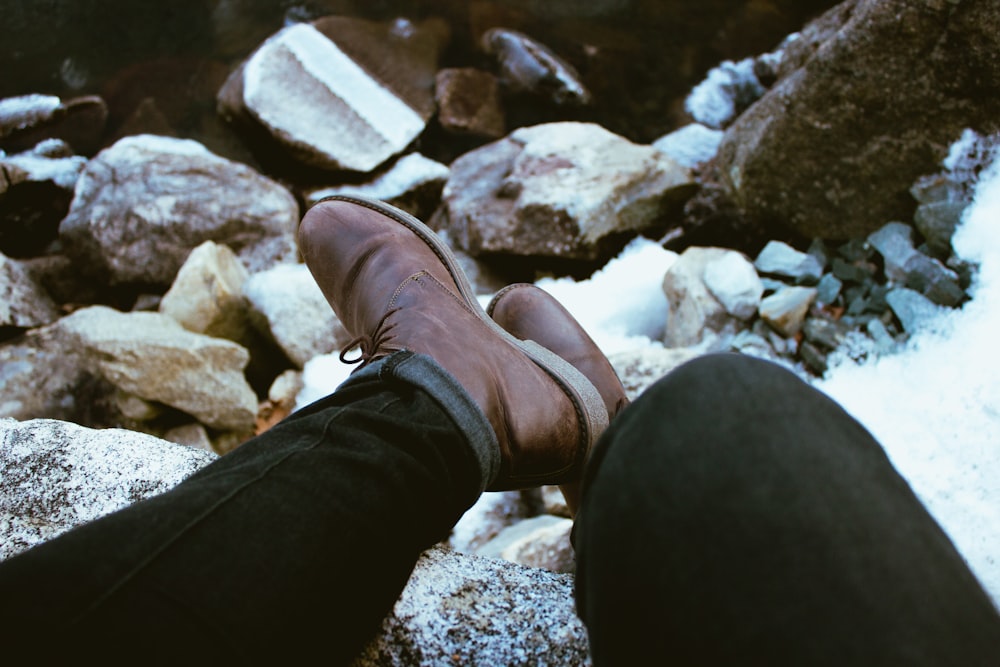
[280,23,426,145]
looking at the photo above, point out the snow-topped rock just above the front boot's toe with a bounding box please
[306,153,449,220]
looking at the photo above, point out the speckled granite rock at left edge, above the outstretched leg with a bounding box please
[0,419,215,559]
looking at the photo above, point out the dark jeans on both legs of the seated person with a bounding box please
[0,353,1000,665]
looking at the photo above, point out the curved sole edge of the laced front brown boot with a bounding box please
[314,195,608,490]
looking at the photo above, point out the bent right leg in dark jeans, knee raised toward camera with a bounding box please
[576,355,1000,665]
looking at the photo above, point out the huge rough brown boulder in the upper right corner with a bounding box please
[717,0,1000,239]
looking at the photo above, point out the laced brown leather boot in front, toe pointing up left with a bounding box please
[299,196,607,491]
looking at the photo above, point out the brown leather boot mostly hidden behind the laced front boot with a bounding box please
[486,283,629,516]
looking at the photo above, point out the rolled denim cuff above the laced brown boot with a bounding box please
[341,351,500,493]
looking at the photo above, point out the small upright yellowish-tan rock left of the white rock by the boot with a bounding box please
[159,241,250,344]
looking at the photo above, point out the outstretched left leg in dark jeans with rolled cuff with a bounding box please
[0,352,499,664]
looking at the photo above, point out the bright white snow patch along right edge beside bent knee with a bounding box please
[817,149,1000,602]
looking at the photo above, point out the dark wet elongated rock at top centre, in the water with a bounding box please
[480,28,591,106]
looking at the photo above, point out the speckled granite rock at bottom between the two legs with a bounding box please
[353,548,591,667]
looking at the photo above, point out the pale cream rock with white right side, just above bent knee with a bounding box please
[663,247,752,347]
